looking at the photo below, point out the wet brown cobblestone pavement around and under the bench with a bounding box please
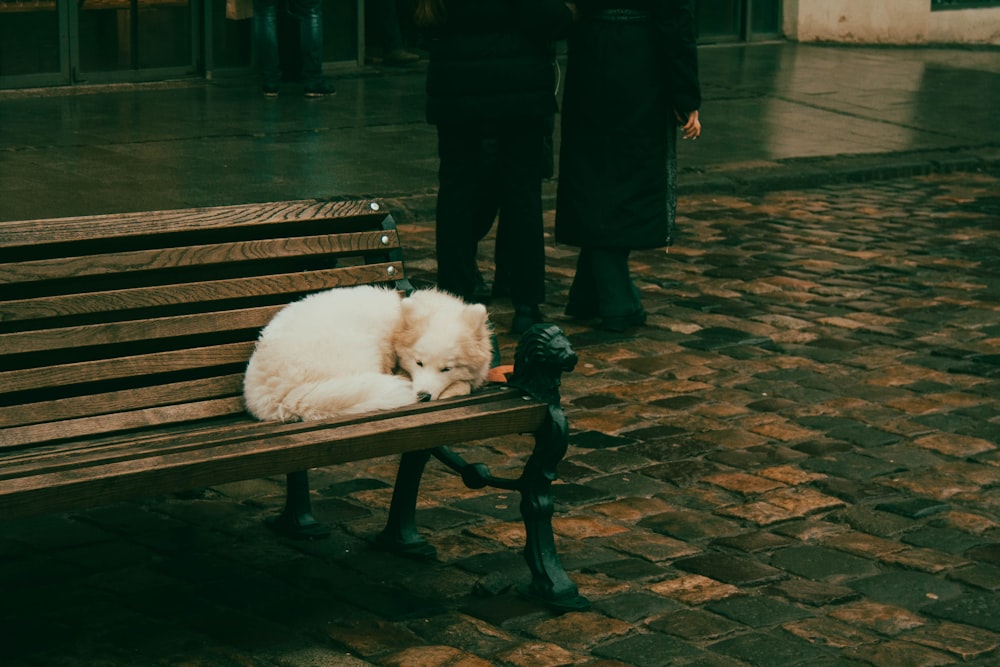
[0,174,1000,667]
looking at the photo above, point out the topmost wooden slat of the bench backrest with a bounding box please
[0,200,388,248]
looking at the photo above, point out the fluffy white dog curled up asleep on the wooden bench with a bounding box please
[243,286,493,421]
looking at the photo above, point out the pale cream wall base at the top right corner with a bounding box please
[784,0,1000,45]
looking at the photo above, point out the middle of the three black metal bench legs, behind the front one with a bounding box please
[375,450,437,558]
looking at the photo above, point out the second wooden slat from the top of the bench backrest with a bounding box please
[0,230,399,284]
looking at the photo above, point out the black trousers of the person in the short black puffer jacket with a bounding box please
[436,118,545,305]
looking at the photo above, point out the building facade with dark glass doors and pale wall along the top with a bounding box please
[0,0,1000,89]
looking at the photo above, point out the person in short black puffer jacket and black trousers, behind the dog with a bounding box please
[415,0,573,333]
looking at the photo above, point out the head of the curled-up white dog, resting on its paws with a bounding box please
[395,290,493,400]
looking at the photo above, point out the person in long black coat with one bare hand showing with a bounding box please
[555,0,701,331]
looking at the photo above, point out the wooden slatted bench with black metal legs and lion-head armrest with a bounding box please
[0,201,587,609]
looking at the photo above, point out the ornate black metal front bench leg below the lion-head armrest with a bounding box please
[521,406,590,611]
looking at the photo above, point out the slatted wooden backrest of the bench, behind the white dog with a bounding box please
[0,201,408,449]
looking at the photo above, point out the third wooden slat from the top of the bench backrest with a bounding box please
[0,262,403,322]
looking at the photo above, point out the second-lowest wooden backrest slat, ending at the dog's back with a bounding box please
[0,374,243,430]
